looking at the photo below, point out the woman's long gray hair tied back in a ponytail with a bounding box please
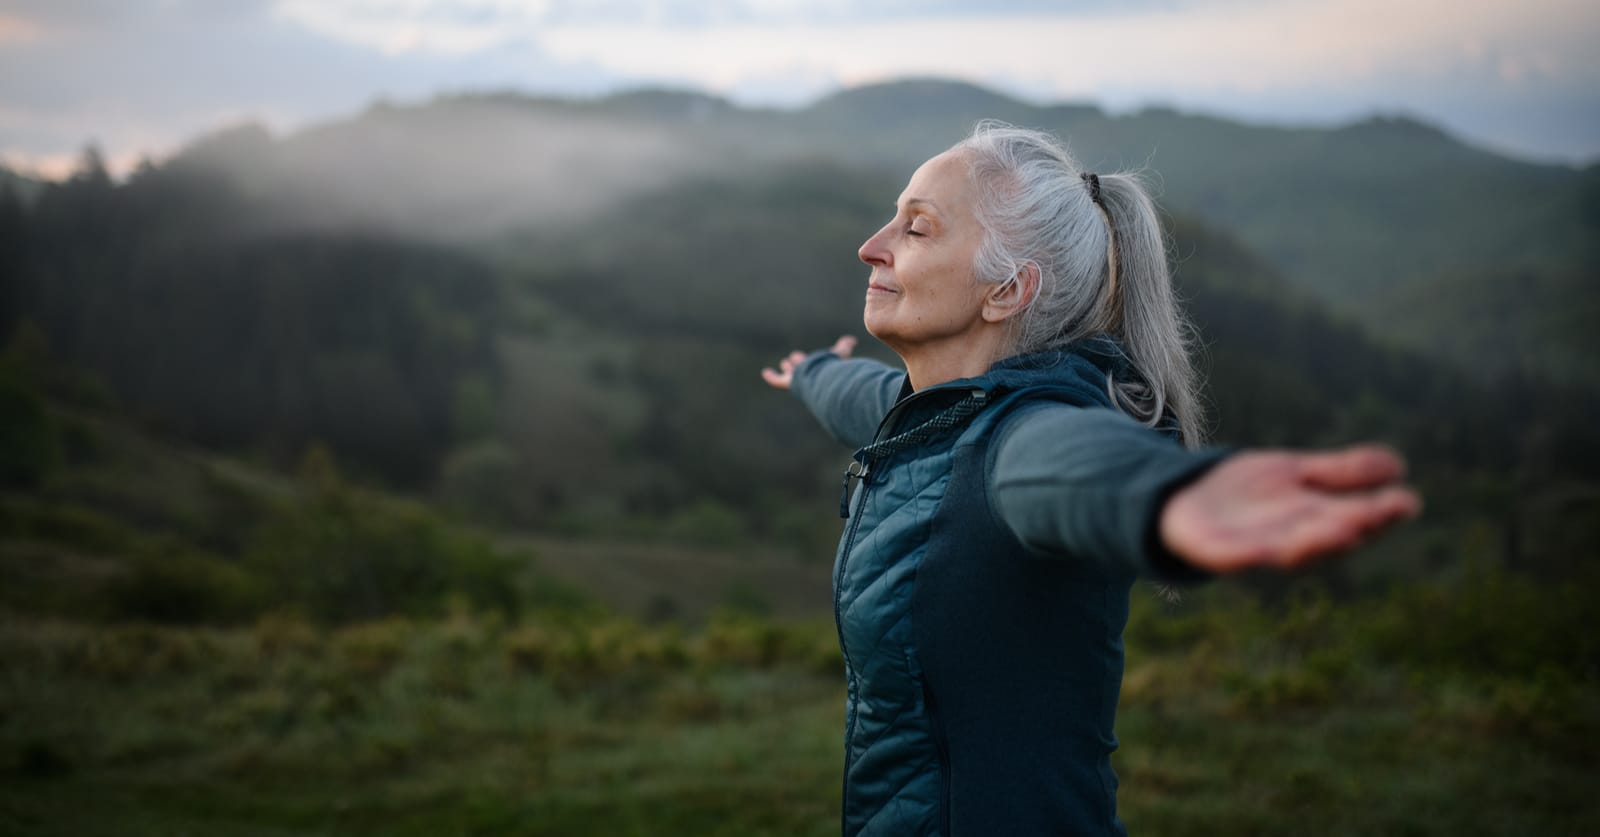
[952,120,1203,447]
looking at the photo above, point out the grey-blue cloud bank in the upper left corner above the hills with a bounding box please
[0,0,616,171]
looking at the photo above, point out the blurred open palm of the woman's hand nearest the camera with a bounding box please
[1160,445,1422,573]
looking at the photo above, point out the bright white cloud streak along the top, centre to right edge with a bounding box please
[541,0,1600,93]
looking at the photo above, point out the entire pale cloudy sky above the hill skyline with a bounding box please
[0,0,1600,176]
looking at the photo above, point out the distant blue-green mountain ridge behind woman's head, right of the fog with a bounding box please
[780,82,1589,314]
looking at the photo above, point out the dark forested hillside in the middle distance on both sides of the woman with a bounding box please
[9,129,1600,588]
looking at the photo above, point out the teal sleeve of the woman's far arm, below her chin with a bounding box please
[789,352,906,448]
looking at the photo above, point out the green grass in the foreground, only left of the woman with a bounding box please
[0,618,843,835]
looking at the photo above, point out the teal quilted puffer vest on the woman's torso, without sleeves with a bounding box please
[834,354,1133,837]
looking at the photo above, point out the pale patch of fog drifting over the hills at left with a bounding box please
[159,96,728,242]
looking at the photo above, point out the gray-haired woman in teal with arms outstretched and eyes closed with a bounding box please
[762,123,1418,837]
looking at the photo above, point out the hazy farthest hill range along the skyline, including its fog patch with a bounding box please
[72,80,1600,386]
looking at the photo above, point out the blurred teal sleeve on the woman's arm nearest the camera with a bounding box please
[989,403,1229,581]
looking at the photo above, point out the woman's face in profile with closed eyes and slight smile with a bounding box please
[859,152,984,355]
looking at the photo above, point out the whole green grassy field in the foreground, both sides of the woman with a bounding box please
[0,573,1600,835]
